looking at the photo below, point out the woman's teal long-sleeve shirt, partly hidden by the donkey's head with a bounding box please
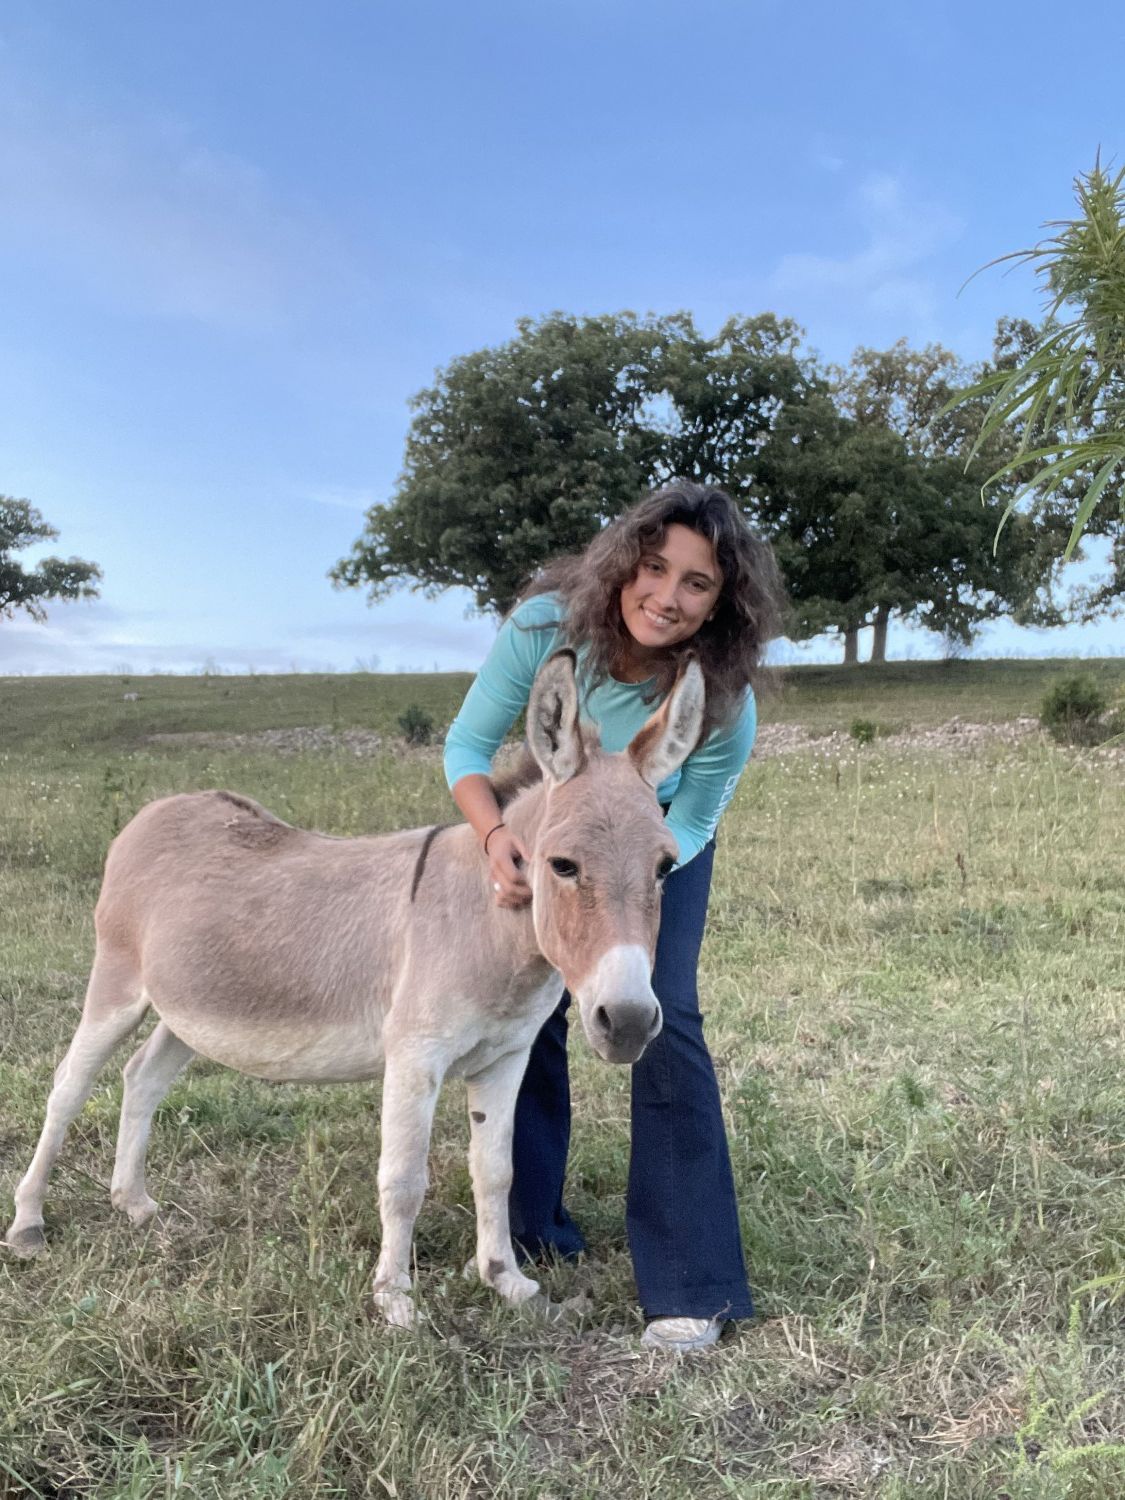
[446,594,758,864]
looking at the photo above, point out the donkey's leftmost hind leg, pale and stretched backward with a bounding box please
[6,954,149,1256]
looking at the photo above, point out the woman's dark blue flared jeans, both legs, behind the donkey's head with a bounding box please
[510,840,753,1319]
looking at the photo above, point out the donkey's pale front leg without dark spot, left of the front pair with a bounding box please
[374,1052,444,1328]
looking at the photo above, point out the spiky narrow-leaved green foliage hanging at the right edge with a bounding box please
[954,161,1125,557]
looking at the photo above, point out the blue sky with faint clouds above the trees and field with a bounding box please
[0,0,1125,674]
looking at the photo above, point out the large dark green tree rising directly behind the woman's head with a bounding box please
[330,312,806,612]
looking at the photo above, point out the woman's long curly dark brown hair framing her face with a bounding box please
[521,480,785,735]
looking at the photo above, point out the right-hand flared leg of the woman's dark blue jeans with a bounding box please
[627,840,753,1319]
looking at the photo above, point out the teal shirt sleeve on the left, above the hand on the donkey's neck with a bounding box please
[444,594,561,788]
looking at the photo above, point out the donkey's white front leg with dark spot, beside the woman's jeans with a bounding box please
[467,1049,539,1302]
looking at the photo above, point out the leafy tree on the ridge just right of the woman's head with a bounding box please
[755,326,1062,662]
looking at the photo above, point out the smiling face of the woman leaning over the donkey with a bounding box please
[621,522,723,654]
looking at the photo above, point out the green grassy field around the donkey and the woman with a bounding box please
[0,662,1125,1500]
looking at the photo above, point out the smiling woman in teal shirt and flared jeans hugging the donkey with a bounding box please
[446,482,782,1350]
